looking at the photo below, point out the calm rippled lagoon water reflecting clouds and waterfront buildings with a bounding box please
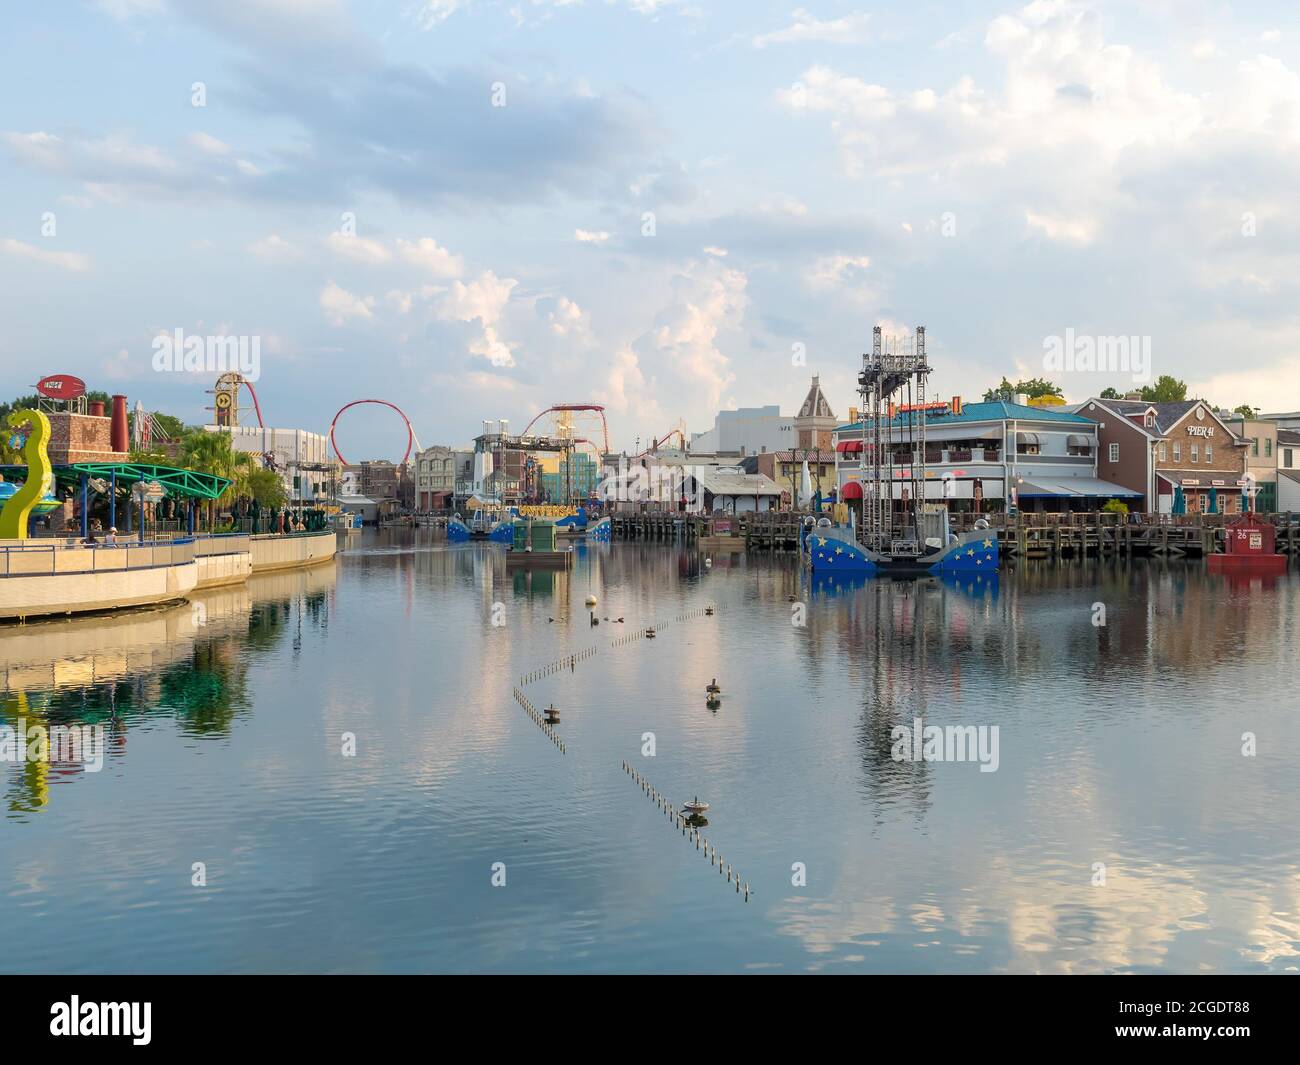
[0,531,1300,973]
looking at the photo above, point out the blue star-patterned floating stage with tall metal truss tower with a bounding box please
[800,325,998,576]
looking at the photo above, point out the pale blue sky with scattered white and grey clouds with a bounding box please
[0,0,1300,460]
